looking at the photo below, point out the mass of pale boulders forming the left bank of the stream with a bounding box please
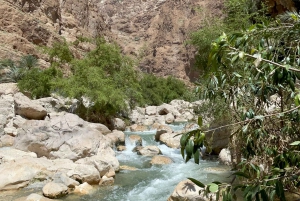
[0,83,125,199]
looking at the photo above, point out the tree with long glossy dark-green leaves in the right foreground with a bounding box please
[181,13,300,201]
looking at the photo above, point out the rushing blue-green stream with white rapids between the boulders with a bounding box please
[0,124,230,201]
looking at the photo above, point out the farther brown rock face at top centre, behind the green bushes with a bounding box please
[100,0,223,80]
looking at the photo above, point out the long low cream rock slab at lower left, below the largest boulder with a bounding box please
[0,148,109,191]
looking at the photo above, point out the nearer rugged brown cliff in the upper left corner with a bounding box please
[0,0,112,63]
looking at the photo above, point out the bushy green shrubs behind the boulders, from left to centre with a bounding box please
[8,38,192,125]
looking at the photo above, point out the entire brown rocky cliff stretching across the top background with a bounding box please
[0,0,297,80]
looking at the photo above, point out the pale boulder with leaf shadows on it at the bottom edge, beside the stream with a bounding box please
[168,180,216,201]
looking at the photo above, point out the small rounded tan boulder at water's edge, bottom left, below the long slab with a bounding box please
[43,182,68,199]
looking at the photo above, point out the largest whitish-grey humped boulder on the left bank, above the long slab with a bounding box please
[14,113,114,161]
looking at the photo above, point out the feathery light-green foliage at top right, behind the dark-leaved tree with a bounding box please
[189,0,266,71]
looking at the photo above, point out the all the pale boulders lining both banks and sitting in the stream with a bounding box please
[0,83,230,201]
